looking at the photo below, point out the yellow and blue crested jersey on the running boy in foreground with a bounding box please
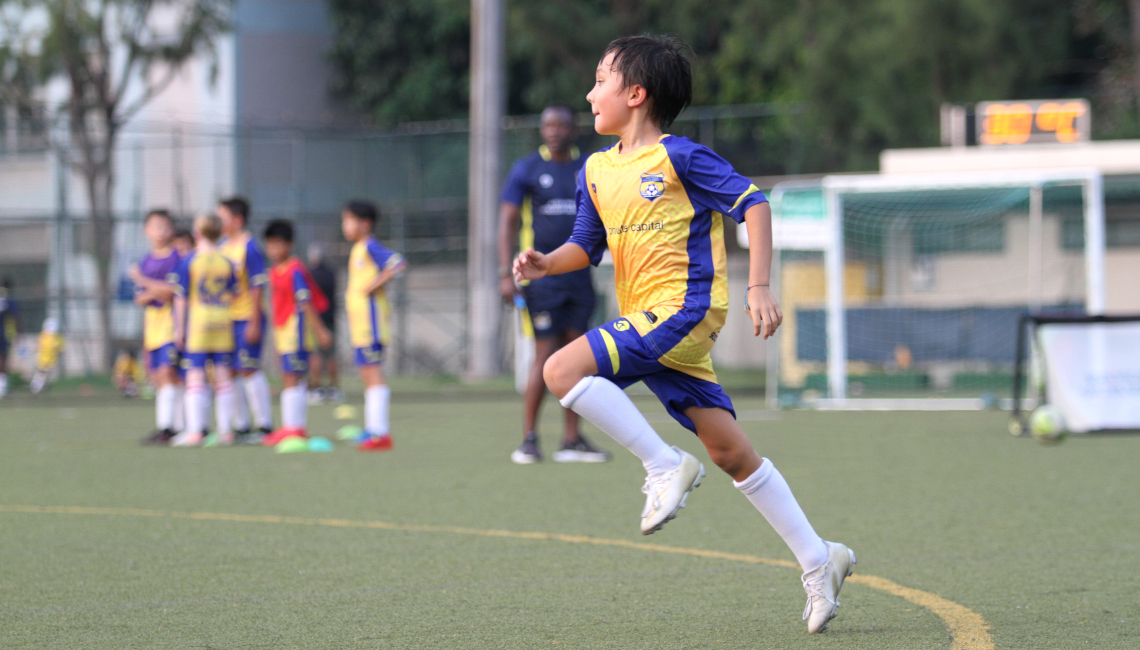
[570,136,767,382]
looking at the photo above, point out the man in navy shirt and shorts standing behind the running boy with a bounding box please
[499,105,610,464]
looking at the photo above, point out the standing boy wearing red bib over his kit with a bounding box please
[261,219,333,447]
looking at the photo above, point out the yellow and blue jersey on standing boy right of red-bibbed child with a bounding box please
[344,236,404,348]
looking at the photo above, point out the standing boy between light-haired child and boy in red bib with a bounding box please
[218,196,274,444]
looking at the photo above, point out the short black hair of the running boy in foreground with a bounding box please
[602,34,693,129]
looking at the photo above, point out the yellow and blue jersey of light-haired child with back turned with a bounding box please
[172,252,237,354]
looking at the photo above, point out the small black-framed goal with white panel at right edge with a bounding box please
[1010,316,1140,434]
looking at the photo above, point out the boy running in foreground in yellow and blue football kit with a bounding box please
[514,36,855,633]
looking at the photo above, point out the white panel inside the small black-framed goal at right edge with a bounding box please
[1037,322,1140,433]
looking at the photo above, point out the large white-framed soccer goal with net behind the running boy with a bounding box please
[741,169,1105,411]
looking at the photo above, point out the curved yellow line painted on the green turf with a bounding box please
[0,505,994,650]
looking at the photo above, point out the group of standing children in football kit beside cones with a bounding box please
[131,197,406,450]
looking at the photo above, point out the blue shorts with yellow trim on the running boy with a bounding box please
[586,318,736,433]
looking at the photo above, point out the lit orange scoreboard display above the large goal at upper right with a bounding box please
[975,99,1092,145]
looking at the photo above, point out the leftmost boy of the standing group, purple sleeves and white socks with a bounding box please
[130,210,182,445]
